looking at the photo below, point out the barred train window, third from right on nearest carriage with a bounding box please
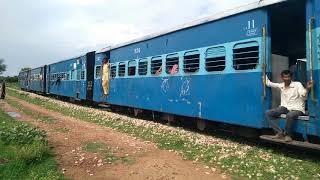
[183,51,200,73]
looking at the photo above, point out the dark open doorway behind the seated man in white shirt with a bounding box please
[268,0,307,108]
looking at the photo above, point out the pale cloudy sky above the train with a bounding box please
[0,0,257,76]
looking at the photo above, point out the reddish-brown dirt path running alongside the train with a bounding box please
[0,97,227,180]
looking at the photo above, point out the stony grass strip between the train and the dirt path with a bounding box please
[8,90,320,179]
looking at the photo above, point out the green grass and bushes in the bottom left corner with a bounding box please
[0,107,64,180]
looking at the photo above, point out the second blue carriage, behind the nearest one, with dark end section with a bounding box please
[47,52,95,101]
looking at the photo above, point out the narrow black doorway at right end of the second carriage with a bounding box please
[86,51,96,101]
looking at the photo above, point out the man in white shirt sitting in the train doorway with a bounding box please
[263,70,313,142]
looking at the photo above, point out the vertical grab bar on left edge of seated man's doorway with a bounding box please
[262,26,267,99]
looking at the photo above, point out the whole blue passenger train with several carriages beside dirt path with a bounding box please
[20,0,320,149]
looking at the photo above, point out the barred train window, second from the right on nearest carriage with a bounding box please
[206,47,226,72]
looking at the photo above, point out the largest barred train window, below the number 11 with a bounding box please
[233,42,259,70]
